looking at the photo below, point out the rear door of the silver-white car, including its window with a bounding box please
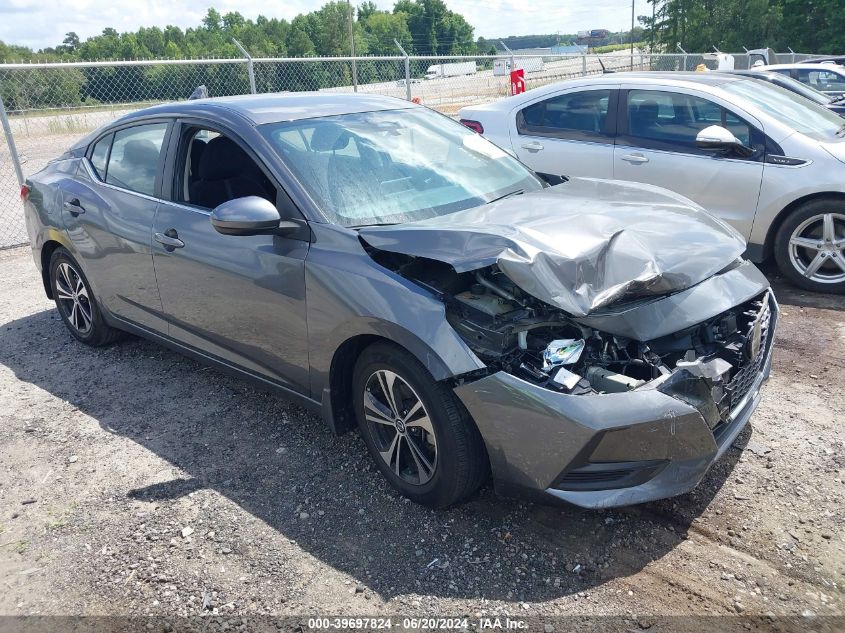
[509,86,618,178]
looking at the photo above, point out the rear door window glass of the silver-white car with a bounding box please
[517,90,613,141]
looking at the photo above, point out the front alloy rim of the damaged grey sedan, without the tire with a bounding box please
[364,369,437,486]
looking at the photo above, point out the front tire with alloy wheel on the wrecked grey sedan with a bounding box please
[353,343,488,508]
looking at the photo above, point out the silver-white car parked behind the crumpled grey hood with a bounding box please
[459,71,845,293]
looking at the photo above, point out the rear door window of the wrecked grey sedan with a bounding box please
[106,123,167,196]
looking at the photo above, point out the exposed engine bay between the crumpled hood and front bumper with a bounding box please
[370,249,768,418]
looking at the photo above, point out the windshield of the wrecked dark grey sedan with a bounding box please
[259,107,544,227]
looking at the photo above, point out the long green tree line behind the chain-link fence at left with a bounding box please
[0,0,484,111]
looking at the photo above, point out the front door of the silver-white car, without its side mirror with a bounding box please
[613,86,765,239]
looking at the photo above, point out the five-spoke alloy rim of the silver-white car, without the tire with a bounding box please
[789,213,845,284]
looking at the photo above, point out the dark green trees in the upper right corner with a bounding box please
[640,0,845,54]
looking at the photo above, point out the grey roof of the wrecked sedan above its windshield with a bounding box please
[112,92,421,125]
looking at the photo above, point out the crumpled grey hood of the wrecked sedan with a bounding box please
[359,178,745,316]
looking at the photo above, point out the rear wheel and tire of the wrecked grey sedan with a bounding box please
[50,248,123,347]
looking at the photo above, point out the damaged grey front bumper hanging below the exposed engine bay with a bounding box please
[455,293,778,508]
